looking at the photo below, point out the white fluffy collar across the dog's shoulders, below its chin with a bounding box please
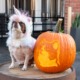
[7,36,36,50]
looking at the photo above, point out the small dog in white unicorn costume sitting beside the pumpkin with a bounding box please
[6,7,36,70]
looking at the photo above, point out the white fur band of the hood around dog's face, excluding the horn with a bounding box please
[8,14,33,35]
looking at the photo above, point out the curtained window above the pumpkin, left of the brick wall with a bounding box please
[42,0,64,17]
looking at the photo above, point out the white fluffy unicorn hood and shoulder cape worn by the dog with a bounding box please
[6,7,36,49]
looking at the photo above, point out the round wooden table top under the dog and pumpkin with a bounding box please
[0,63,76,80]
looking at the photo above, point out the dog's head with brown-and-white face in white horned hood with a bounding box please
[8,6,33,38]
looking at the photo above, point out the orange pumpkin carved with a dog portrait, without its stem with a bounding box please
[34,31,76,73]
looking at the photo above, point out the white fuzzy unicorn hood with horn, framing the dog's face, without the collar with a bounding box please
[8,5,33,35]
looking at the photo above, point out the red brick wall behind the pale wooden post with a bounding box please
[64,0,80,32]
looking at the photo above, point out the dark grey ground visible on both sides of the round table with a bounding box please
[0,39,80,80]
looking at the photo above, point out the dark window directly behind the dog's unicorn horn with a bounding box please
[6,0,31,15]
